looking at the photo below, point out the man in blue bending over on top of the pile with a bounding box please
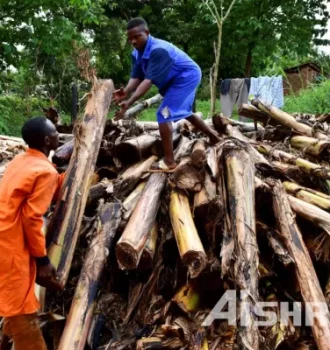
[114,18,220,172]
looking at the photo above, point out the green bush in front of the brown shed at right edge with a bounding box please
[283,80,330,114]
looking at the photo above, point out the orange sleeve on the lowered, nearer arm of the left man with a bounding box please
[22,173,57,257]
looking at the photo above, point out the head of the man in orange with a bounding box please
[22,117,59,154]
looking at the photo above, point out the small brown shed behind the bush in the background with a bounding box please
[283,62,321,95]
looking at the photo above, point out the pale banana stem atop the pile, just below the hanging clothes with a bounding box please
[252,99,329,140]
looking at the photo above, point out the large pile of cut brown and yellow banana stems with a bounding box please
[4,93,330,350]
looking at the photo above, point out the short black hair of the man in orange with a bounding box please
[22,117,51,149]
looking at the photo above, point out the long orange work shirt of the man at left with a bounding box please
[0,149,64,317]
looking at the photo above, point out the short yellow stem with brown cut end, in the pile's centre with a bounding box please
[170,190,207,278]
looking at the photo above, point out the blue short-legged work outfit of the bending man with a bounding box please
[131,35,202,124]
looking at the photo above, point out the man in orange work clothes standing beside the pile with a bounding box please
[0,117,64,350]
